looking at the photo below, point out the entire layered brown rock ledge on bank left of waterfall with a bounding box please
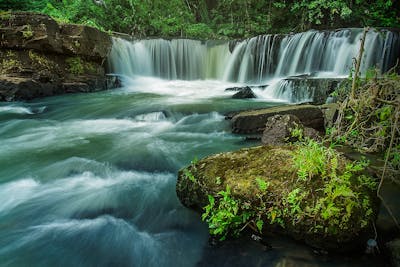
[0,12,112,101]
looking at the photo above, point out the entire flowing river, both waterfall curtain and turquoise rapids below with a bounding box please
[0,30,396,266]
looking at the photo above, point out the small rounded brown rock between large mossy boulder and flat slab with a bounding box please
[261,114,320,145]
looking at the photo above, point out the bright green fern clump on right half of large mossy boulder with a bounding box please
[290,140,377,233]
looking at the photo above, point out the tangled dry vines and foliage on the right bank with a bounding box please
[329,73,400,176]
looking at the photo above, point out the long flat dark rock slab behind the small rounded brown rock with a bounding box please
[231,105,324,134]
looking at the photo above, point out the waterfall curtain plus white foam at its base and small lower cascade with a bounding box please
[109,29,400,103]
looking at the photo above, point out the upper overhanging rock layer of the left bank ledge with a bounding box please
[0,12,112,62]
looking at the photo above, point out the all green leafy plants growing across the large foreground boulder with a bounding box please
[202,140,377,239]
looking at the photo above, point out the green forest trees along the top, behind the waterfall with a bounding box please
[0,0,400,38]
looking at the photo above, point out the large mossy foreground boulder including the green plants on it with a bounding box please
[176,141,378,251]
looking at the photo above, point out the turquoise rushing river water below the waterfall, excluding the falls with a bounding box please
[0,79,282,266]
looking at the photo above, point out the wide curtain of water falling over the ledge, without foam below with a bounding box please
[109,28,400,84]
